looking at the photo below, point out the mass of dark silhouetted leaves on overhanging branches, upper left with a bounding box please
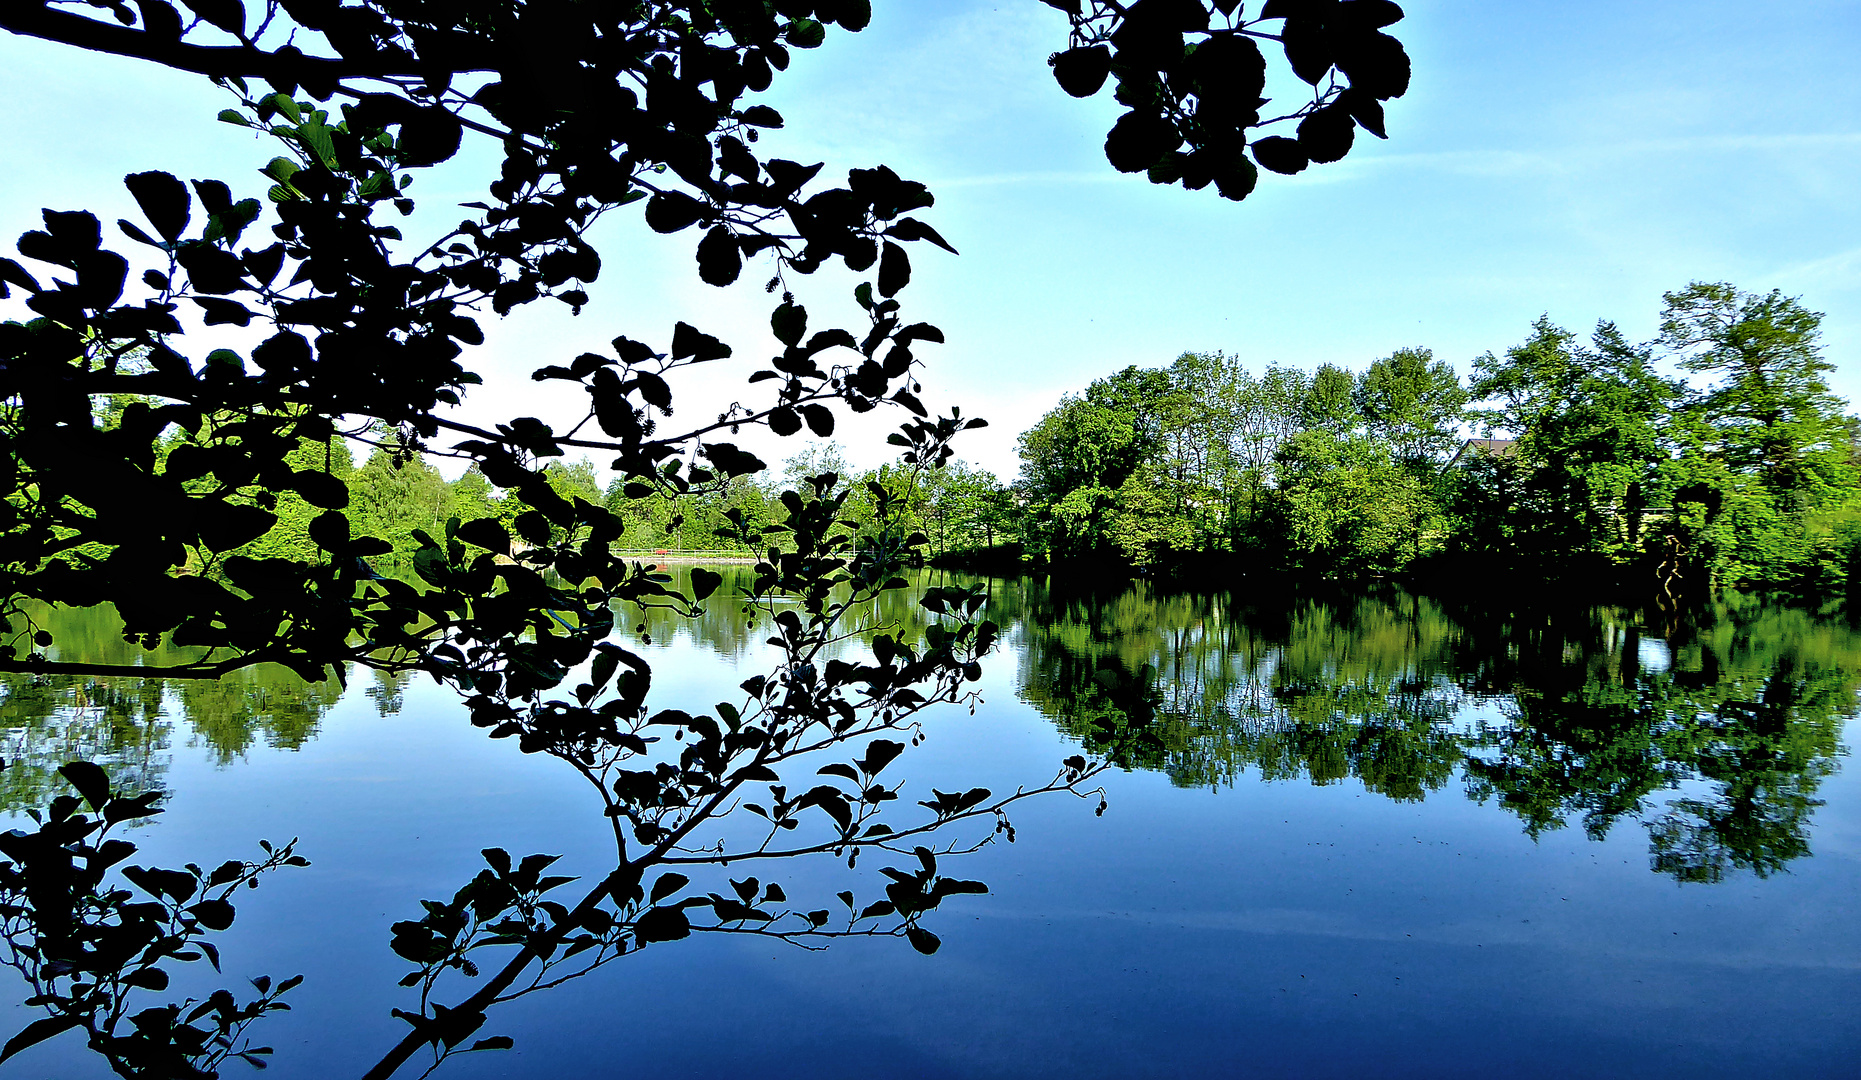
[0,2,982,695]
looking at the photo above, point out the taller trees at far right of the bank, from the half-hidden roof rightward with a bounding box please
[1455,283,1861,596]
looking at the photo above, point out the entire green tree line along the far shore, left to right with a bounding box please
[148,283,1861,596]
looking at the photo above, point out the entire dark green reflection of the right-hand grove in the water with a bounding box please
[997,581,1861,881]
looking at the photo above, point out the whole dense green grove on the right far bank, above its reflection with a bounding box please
[1014,285,1861,598]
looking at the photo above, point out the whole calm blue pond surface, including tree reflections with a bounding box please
[0,572,1861,1078]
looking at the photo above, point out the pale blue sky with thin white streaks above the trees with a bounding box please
[0,0,1861,475]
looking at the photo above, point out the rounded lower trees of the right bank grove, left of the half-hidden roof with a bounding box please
[1018,350,1465,574]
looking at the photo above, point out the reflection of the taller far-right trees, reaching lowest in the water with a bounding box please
[1466,601,1861,883]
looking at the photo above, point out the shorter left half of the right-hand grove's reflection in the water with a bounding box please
[1016,583,1461,799]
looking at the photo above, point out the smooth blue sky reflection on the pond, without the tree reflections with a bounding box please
[9,580,1861,1080]
